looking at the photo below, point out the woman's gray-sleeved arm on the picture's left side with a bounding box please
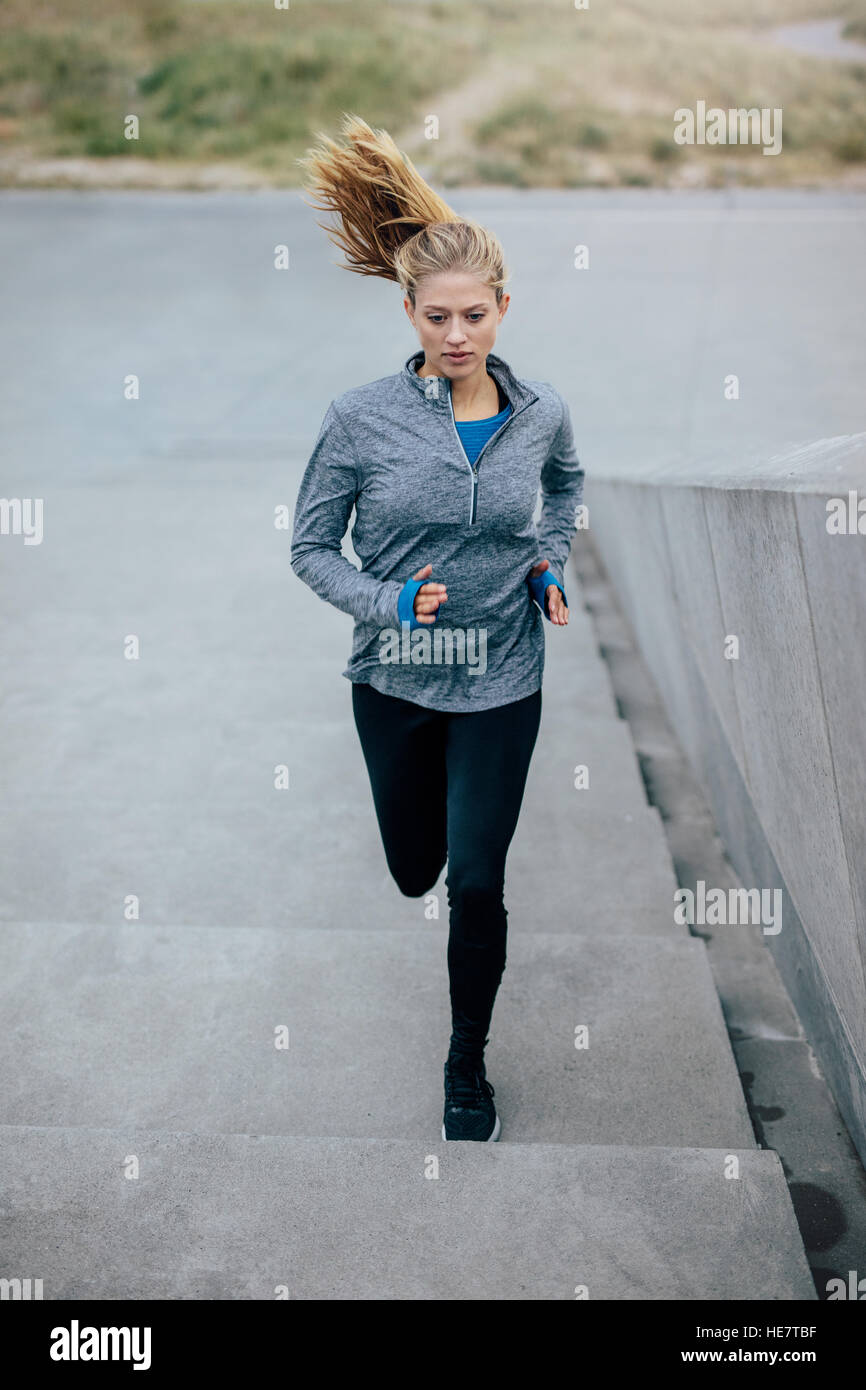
[292,402,405,627]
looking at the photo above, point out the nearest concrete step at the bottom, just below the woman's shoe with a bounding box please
[0,1125,816,1301]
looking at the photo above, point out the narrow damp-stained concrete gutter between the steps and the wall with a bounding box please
[573,530,866,1297]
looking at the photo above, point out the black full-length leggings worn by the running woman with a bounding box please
[352,682,541,1059]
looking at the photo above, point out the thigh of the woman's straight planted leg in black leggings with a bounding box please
[445,689,541,887]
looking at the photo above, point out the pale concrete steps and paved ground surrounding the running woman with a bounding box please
[0,192,863,1300]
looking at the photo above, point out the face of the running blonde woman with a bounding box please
[403,271,512,377]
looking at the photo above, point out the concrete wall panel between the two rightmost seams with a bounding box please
[708,489,866,1061]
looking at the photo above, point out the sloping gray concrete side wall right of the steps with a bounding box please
[589,435,866,1162]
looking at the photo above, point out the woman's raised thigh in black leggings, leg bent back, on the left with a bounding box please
[352,681,448,898]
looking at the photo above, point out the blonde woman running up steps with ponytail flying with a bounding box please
[292,115,584,1143]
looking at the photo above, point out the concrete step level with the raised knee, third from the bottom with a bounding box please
[0,789,678,935]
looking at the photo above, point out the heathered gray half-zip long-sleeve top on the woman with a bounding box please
[292,352,584,712]
